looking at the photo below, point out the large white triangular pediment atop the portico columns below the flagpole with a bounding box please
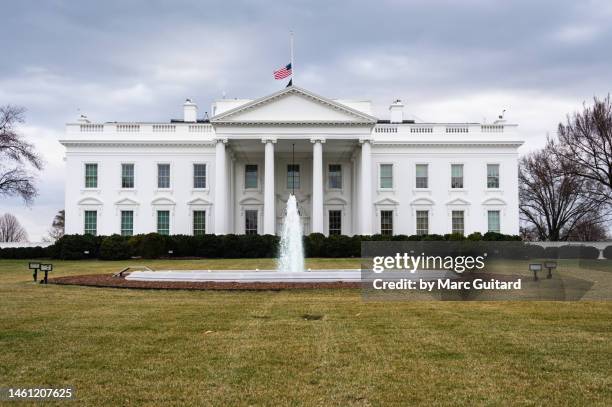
[211,86,376,125]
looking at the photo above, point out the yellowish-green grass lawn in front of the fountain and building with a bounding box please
[0,259,612,406]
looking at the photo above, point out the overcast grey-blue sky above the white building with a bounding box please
[0,0,612,241]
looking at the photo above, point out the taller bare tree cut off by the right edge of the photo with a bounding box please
[554,95,612,205]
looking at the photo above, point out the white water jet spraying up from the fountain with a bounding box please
[278,194,304,273]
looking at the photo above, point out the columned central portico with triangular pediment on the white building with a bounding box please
[211,88,376,234]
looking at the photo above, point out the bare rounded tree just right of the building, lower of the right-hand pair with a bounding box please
[519,140,604,241]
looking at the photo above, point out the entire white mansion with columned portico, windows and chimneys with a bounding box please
[60,86,522,239]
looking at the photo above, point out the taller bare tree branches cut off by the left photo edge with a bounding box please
[0,105,43,203]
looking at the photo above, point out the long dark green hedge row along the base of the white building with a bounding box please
[0,232,612,260]
